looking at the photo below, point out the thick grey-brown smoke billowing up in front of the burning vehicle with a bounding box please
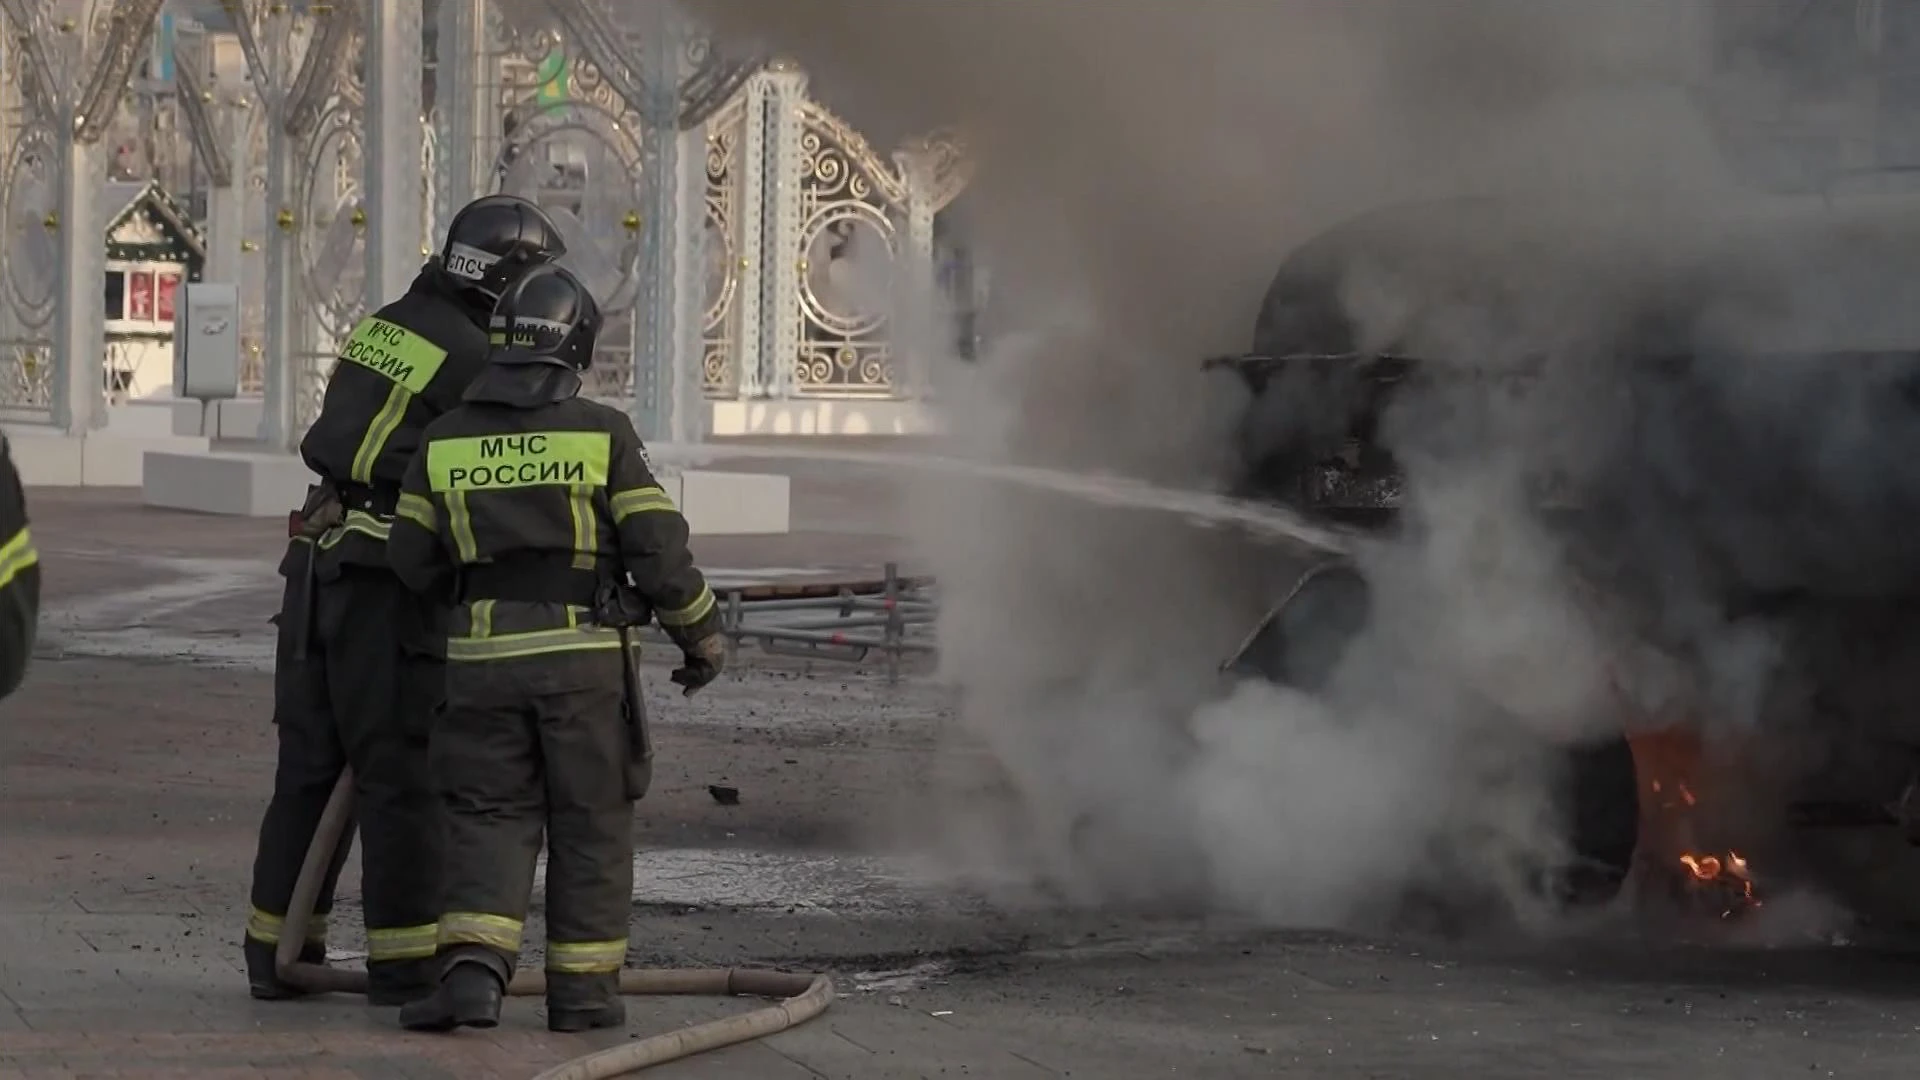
[689,0,1881,922]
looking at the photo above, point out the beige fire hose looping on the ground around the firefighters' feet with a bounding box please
[273,769,833,1080]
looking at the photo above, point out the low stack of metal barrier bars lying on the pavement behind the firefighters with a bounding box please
[645,563,939,682]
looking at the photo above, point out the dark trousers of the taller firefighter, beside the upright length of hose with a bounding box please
[246,540,445,992]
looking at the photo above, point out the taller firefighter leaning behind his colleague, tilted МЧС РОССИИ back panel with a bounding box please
[244,196,566,1005]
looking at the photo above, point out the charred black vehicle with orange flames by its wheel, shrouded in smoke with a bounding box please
[1208,196,1920,915]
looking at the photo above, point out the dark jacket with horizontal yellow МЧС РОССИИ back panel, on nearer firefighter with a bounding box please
[388,382,718,663]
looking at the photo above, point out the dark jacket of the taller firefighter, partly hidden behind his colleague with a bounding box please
[282,261,488,578]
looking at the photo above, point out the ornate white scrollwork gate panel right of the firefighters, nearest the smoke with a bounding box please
[701,61,970,398]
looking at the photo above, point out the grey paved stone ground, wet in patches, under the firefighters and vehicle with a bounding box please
[0,469,1920,1080]
